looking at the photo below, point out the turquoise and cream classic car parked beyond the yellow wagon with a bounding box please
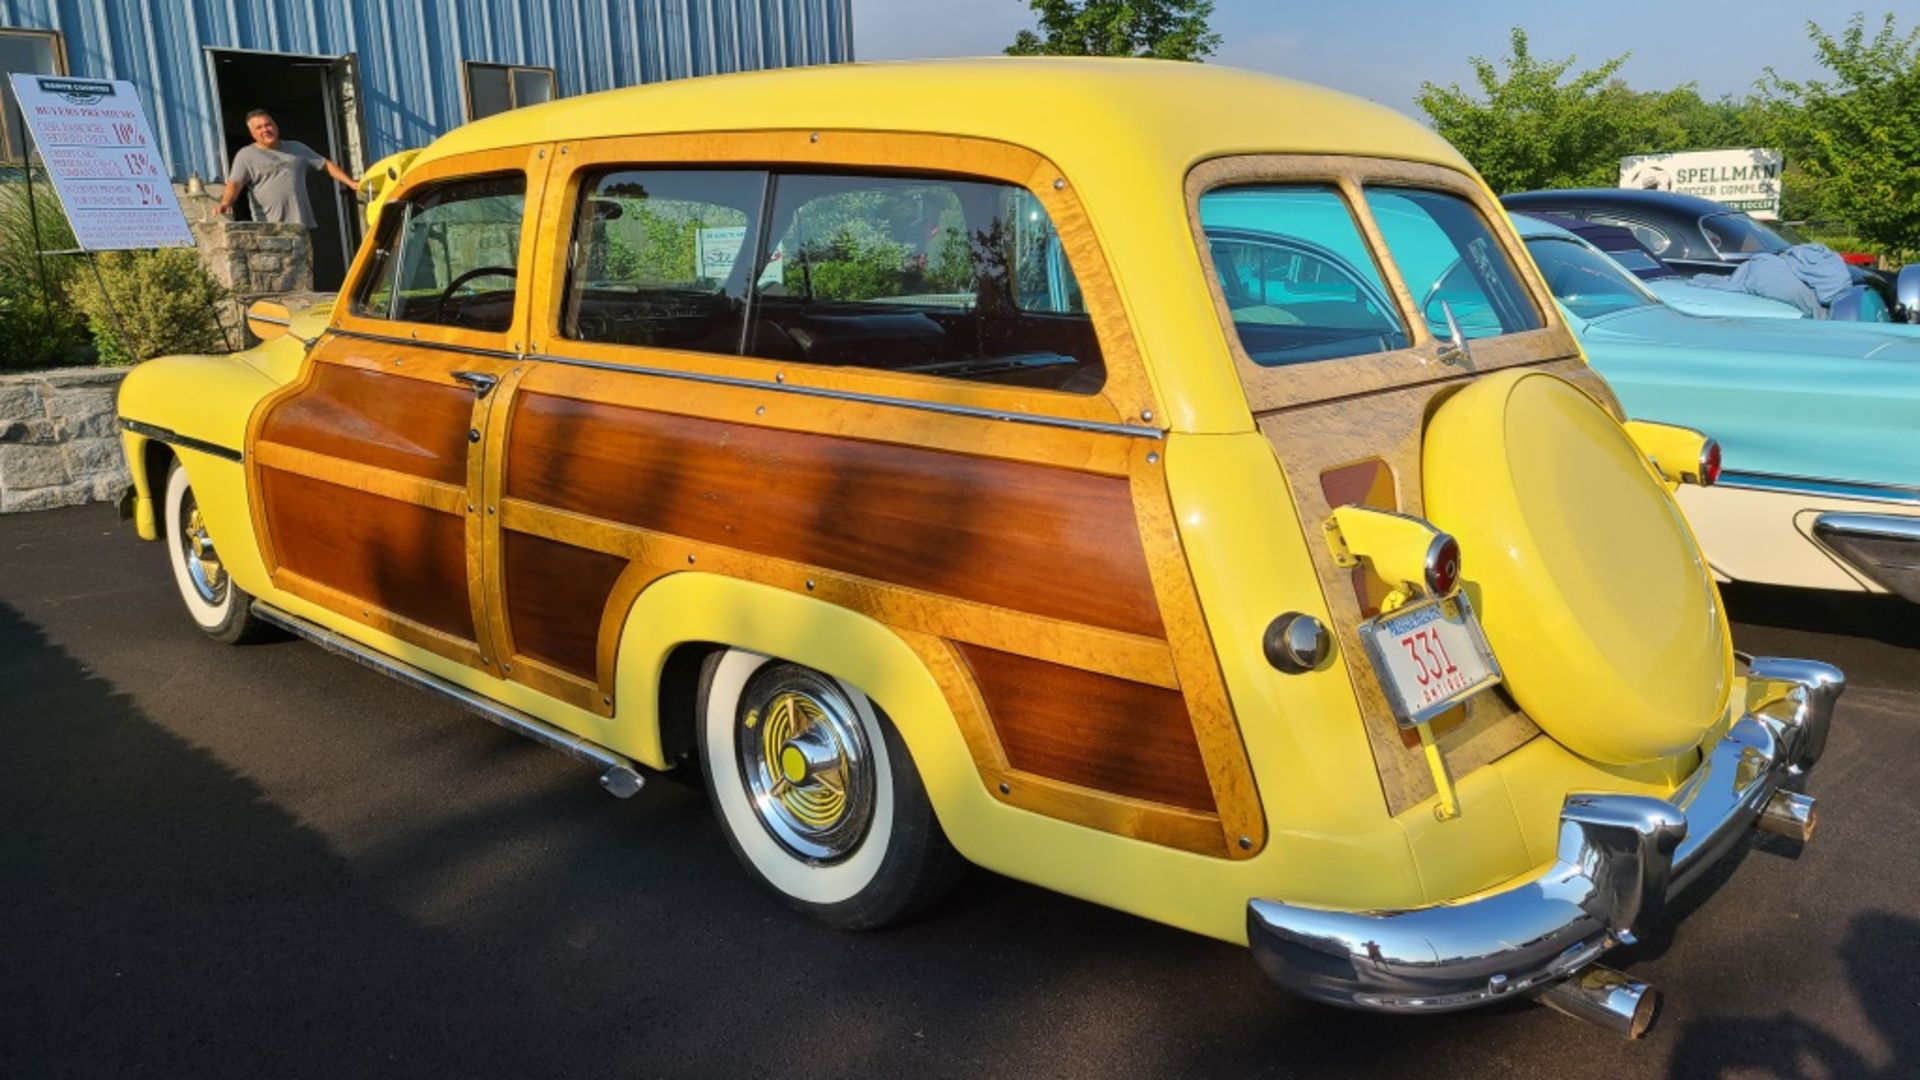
[1512,215,1920,603]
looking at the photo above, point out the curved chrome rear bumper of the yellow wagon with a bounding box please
[1246,657,1847,1013]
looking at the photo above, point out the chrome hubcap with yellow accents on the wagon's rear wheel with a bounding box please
[735,669,874,863]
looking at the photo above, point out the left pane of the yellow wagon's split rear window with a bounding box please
[1200,184,1407,367]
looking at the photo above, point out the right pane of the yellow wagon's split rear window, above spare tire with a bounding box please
[1367,186,1542,338]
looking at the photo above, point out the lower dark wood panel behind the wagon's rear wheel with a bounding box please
[958,644,1217,807]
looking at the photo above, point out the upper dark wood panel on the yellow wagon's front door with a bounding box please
[257,363,474,486]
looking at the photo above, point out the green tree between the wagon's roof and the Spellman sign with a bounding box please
[1419,27,1651,192]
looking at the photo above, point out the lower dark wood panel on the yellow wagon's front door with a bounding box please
[259,467,474,642]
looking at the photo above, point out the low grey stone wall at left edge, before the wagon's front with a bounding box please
[0,367,132,513]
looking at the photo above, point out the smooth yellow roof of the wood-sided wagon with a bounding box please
[420,58,1465,173]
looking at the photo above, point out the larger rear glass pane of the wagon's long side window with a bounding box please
[747,173,1106,394]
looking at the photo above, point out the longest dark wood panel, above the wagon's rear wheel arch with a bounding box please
[505,392,1164,636]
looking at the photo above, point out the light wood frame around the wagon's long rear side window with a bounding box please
[528,131,1160,425]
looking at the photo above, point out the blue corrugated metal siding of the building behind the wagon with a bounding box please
[0,0,852,181]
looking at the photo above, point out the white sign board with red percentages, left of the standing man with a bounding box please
[13,75,194,252]
